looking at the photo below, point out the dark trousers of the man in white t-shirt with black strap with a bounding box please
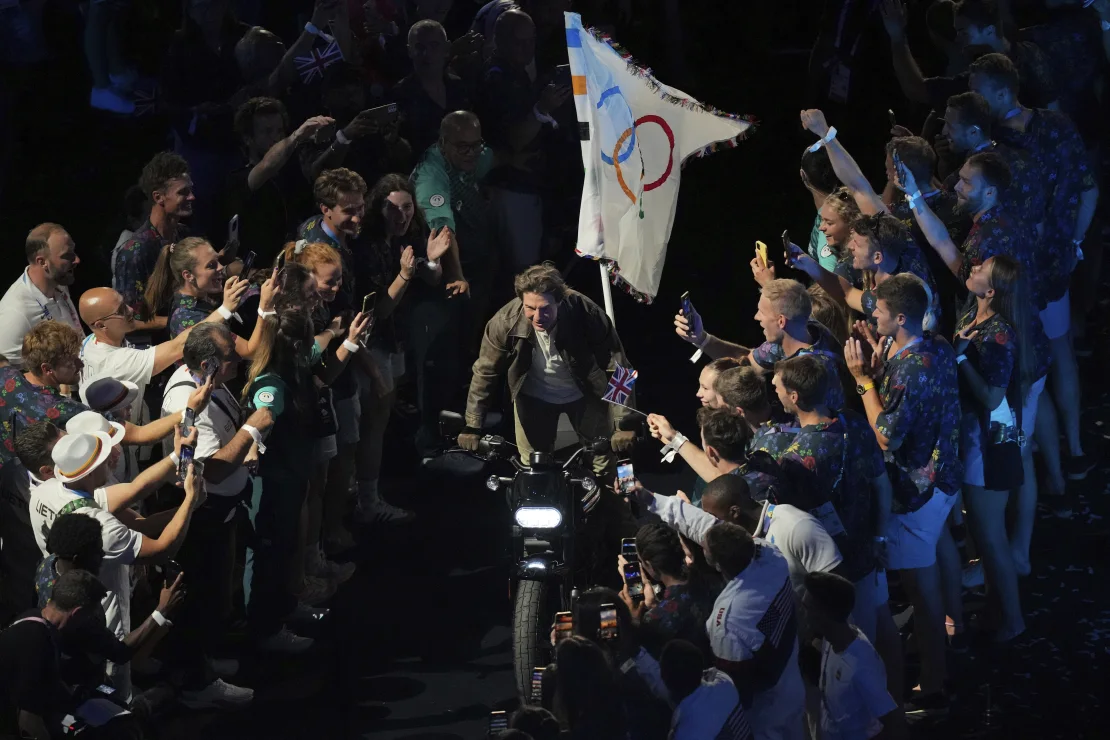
[167,495,242,689]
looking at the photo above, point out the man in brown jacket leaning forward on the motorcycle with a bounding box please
[458,263,636,475]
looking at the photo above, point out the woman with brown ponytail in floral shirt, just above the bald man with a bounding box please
[144,236,251,350]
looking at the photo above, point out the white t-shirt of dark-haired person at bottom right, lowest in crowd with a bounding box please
[819,628,898,740]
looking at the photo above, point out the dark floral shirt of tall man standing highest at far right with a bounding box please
[996,110,1096,302]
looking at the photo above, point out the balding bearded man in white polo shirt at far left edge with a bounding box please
[0,223,84,367]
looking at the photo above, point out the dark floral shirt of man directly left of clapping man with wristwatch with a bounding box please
[778,412,886,581]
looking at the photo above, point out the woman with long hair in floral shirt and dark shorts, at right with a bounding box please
[946,255,1037,642]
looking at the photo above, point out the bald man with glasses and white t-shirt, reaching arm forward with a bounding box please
[79,287,223,424]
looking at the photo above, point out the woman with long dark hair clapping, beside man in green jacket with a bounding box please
[348,174,451,524]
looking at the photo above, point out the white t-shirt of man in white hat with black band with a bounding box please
[31,478,142,639]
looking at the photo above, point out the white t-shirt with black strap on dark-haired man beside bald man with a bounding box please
[162,365,249,496]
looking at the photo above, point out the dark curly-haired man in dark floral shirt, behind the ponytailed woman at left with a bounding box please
[112,152,196,331]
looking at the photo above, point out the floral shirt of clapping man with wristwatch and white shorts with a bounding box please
[875,332,963,514]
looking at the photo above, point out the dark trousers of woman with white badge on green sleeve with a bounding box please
[245,468,306,637]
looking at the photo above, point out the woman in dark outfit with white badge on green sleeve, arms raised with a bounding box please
[243,270,370,652]
